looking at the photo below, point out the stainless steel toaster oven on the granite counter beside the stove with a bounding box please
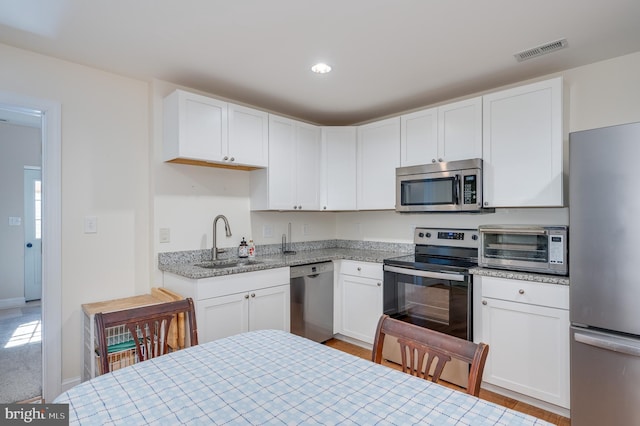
[478,225,569,275]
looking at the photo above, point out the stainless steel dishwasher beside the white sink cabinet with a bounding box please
[291,262,333,342]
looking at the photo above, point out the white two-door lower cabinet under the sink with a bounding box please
[164,268,290,343]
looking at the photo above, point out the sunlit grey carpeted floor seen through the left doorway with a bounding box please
[0,302,42,404]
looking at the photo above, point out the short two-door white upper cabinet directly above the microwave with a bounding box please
[400,97,482,166]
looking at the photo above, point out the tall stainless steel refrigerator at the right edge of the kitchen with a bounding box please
[569,123,640,426]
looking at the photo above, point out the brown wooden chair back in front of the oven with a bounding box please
[371,315,489,396]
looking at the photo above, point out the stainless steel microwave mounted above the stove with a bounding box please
[396,158,494,213]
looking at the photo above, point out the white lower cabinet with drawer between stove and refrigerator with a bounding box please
[474,276,569,409]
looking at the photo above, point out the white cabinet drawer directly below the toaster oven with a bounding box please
[481,277,569,309]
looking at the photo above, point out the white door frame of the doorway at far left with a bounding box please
[0,91,62,402]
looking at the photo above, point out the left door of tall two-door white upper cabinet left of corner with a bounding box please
[268,115,297,210]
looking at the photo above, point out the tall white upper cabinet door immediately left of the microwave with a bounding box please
[357,117,400,210]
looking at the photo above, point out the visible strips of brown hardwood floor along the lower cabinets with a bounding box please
[325,339,571,426]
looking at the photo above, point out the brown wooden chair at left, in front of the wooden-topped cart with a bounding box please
[95,298,198,374]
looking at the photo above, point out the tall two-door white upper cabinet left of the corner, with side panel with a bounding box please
[251,114,320,210]
